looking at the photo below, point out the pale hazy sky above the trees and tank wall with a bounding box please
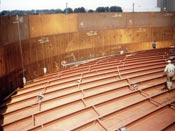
[0,0,160,12]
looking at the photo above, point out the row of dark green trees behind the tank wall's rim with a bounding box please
[0,6,123,16]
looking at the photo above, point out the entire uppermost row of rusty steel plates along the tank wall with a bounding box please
[0,13,175,44]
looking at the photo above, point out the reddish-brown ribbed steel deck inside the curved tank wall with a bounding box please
[0,49,175,131]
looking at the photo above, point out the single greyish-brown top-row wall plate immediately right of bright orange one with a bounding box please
[78,13,126,31]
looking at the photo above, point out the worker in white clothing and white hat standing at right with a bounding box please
[164,60,175,90]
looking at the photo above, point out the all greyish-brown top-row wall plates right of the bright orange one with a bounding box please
[78,12,175,31]
